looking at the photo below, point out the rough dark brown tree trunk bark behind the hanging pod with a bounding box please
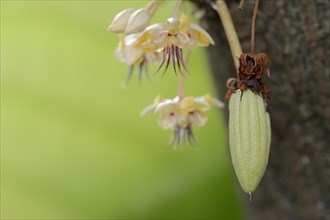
[192,0,330,220]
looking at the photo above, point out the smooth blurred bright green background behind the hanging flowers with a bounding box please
[1,1,241,219]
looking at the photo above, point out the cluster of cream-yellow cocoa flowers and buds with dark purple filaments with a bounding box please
[108,1,223,145]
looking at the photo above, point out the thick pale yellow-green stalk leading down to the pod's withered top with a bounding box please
[216,0,243,78]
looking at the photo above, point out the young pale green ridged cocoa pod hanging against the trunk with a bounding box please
[229,89,271,193]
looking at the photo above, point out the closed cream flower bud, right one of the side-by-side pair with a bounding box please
[125,8,151,34]
